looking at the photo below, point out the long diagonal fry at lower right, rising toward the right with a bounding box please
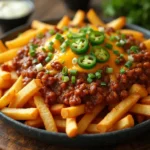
[97,94,140,132]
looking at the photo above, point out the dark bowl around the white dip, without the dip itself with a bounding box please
[0,0,34,32]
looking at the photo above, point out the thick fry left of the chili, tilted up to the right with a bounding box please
[9,79,42,108]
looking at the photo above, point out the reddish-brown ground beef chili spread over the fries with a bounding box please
[7,28,150,112]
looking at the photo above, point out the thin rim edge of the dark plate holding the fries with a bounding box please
[0,18,150,144]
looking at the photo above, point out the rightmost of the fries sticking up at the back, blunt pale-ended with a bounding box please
[106,16,126,30]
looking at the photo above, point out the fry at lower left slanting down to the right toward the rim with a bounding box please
[34,96,57,132]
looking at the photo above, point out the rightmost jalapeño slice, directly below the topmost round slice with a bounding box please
[92,46,110,63]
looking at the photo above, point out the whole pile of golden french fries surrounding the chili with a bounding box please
[0,9,150,137]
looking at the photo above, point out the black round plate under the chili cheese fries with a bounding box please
[0,20,150,147]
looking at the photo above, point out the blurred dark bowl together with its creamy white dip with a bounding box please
[0,0,34,32]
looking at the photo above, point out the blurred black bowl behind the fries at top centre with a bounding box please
[64,0,90,11]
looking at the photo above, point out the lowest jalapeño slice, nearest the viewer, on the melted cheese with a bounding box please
[78,55,96,69]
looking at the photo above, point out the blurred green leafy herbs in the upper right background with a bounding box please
[102,0,150,29]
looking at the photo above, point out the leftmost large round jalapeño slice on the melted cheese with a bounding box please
[70,38,89,55]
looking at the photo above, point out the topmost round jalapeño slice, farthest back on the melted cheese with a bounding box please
[89,31,105,45]
